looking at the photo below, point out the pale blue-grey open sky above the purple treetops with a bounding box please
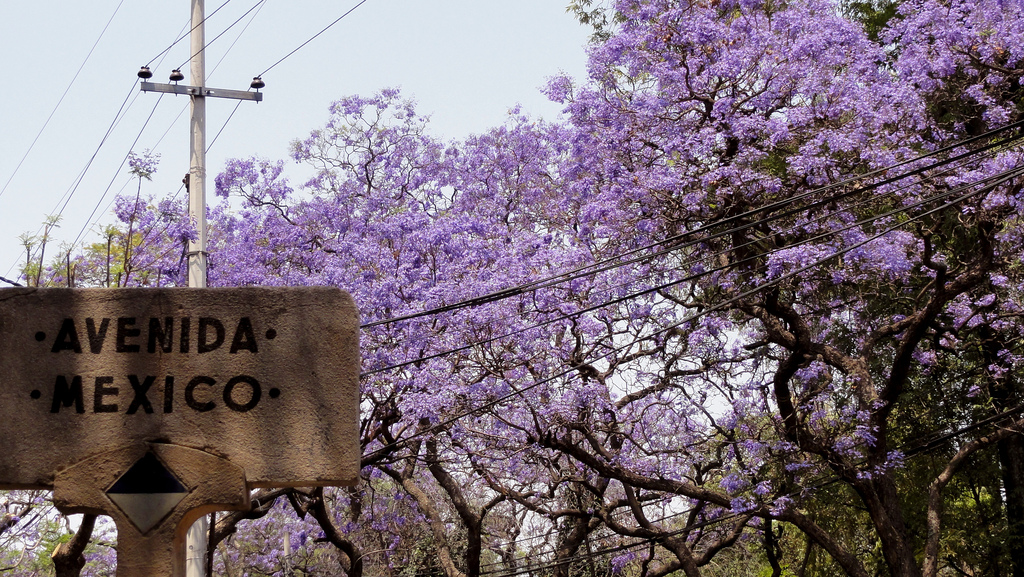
[0,0,588,286]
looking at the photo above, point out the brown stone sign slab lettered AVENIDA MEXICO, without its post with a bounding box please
[0,287,359,489]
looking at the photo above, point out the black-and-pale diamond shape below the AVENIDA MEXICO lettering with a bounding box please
[106,453,188,534]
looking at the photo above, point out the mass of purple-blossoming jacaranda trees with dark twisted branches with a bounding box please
[14,0,1024,577]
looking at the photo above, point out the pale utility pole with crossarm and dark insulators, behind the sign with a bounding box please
[138,0,264,577]
